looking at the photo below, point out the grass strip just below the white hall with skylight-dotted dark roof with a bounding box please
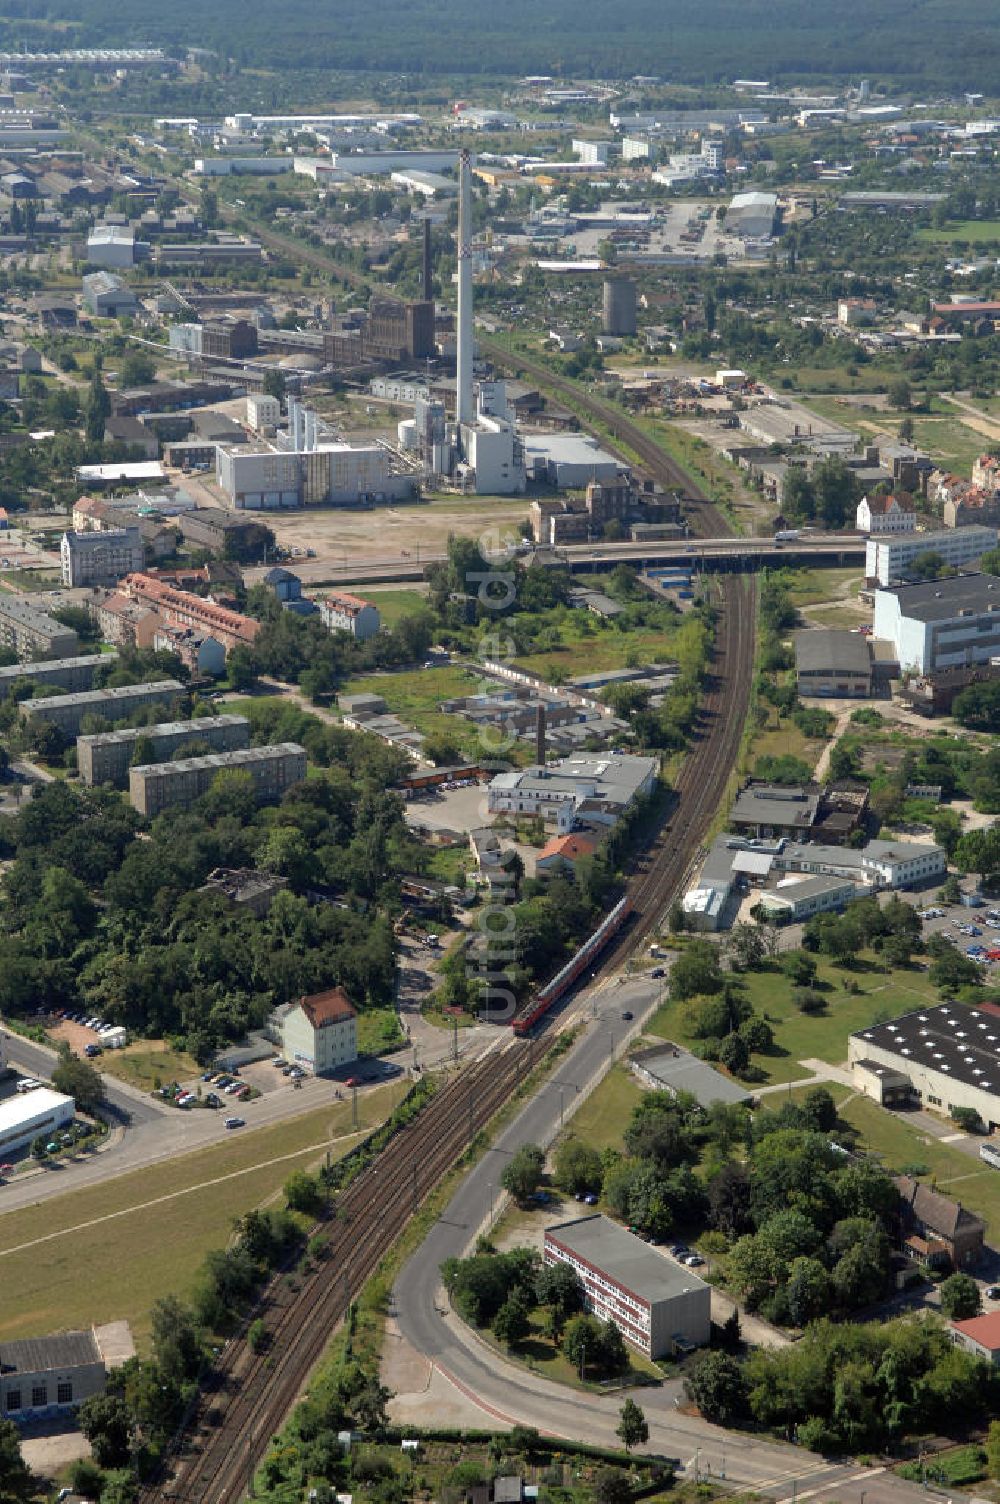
[841,1096,1000,1242]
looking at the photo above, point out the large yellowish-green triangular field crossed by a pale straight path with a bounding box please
[0,1083,406,1348]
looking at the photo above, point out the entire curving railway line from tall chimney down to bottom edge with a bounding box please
[141,341,755,1504]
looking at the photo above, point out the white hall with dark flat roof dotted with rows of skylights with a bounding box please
[848,1003,1000,1131]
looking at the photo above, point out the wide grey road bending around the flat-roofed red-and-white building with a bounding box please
[392,978,926,1504]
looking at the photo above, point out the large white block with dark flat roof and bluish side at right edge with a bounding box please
[872,571,1000,674]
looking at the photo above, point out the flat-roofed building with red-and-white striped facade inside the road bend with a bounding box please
[543,1214,711,1358]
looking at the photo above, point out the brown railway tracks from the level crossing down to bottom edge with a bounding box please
[141,1036,553,1504]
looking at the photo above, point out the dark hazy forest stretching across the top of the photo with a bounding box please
[0,0,1000,93]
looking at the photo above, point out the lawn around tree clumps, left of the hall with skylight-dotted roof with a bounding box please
[647,957,937,1084]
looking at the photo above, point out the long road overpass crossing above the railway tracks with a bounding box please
[284,532,868,585]
